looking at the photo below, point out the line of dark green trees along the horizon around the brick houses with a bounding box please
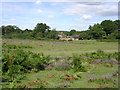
[0,20,120,40]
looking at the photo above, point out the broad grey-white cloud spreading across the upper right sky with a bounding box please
[64,3,118,16]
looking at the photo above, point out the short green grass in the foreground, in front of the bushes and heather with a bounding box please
[22,65,117,88]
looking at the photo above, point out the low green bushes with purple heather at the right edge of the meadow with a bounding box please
[81,49,120,66]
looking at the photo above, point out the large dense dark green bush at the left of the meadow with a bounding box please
[2,49,50,81]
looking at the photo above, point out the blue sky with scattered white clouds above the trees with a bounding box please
[0,0,118,31]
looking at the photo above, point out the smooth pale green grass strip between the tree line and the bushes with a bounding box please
[3,39,118,57]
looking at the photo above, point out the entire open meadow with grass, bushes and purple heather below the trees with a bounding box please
[2,39,119,88]
